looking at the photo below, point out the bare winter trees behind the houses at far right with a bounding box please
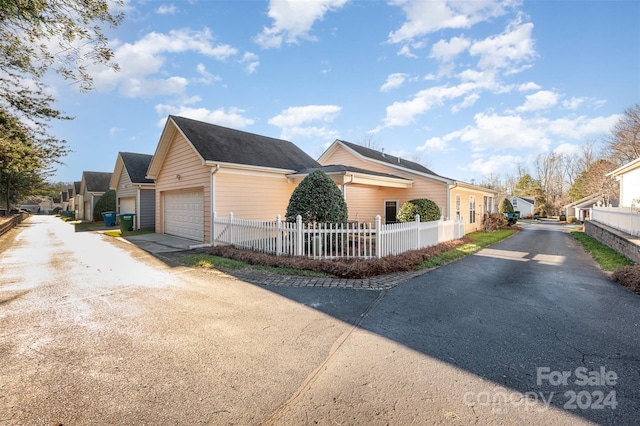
[481,104,640,215]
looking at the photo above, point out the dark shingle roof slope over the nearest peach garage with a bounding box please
[169,115,320,170]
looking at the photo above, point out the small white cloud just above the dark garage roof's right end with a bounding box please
[268,105,342,139]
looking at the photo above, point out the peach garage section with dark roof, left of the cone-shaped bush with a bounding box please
[146,116,319,244]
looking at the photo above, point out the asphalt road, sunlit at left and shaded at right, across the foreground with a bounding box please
[0,216,640,425]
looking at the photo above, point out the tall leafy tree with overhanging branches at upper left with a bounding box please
[0,0,124,214]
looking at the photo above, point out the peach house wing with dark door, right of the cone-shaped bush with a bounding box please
[318,140,497,232]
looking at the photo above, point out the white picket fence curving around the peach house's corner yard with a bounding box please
[213,213,464,259]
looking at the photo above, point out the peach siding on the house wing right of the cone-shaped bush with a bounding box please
[323,146,448,220]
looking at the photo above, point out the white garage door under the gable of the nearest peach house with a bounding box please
[164,190,204,242]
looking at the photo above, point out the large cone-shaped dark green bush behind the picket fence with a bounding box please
[286,170,348,223]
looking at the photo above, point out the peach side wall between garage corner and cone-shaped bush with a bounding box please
[215,168,296,220]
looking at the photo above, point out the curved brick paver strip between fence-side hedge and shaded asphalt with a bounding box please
[227,269,427,290]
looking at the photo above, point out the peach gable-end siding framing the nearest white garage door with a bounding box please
[156,132,211,242]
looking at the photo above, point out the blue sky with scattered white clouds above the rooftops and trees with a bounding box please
[49,0,640,182]
